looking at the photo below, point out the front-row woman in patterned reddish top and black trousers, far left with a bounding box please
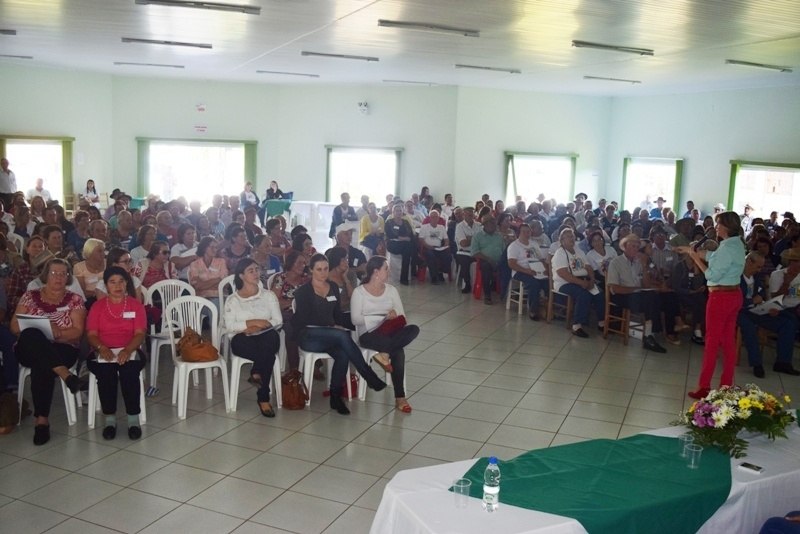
[10,258,86,445]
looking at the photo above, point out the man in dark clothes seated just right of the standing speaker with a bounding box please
[736,252,800,378]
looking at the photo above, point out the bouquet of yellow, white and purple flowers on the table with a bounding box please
[677,384,795,458]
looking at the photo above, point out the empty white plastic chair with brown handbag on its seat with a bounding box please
[164,296,231,419]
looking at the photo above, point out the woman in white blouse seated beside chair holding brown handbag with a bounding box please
[223,258,283,417]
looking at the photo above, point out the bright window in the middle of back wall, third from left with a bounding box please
[326,146,402,206]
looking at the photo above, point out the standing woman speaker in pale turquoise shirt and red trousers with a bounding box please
[677,211,745,399]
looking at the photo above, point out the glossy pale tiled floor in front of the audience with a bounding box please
[0,285,800,534]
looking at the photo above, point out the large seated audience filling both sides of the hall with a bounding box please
[0,163,800,444]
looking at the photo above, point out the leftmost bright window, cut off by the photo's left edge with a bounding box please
[0,136,73,206]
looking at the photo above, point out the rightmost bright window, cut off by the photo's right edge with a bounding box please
[728,161,800,219]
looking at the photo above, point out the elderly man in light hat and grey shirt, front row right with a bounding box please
[606,234,676,353]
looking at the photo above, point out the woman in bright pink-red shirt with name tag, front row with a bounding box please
[86,265,147,440]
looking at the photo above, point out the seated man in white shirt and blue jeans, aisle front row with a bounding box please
[507,223,548,321]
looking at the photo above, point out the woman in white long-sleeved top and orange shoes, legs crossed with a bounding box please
[350,256,419,413]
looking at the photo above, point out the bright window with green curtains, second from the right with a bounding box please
[622,158,683,217]
